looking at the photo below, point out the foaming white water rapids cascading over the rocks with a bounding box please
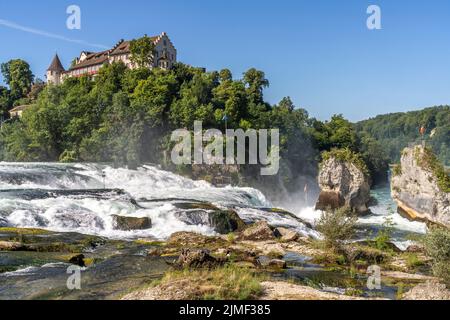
[0,163,425,248]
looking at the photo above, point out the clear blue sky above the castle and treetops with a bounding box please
[0,0,450,120]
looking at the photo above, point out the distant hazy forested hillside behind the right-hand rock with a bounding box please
[356,106,450,166]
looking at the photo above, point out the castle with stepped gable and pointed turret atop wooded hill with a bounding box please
[46,32,177,85]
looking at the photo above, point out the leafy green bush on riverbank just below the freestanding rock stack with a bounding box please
[316,207,358,249]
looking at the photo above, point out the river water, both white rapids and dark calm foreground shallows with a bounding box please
[0,163,426,299]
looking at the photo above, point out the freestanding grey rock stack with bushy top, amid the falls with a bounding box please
[316,157,370,214]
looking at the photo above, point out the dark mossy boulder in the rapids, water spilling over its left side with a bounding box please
[175,209,245,234]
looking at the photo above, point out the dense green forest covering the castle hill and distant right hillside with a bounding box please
[0,39,450,195]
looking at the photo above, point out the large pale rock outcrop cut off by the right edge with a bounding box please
[391,146,450,227]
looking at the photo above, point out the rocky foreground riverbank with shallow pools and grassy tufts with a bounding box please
[0,222,446,300]
